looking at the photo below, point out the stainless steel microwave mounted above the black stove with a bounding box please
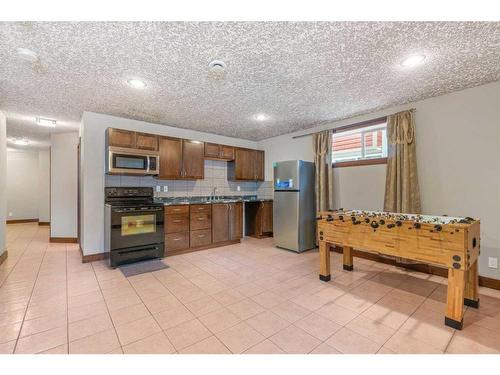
[106,147,160,176]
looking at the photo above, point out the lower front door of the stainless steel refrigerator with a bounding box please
[273,191,299,251]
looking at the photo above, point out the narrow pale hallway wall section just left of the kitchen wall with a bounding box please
[50,133,78,237]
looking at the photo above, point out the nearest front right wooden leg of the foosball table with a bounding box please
[444,268,465,330]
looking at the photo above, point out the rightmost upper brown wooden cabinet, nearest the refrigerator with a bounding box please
[230,148,264,181]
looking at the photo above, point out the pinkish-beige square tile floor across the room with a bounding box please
[0,224,500,354]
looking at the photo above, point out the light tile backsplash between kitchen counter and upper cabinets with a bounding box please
[105,160,273,198]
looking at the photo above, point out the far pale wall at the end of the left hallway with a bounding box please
[7,149,39,220]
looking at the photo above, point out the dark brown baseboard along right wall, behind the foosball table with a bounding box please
[330,246,500,290]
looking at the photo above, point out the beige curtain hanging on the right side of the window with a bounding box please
[384,111,421,214]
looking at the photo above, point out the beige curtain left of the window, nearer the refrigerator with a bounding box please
[313,130,333,211]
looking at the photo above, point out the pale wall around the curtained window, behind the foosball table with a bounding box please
[260,82,500,279]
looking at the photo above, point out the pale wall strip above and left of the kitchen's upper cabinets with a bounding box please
[80,112,258,255]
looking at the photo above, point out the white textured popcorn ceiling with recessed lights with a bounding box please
[0,22,500,146]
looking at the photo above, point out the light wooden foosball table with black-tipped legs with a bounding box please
[317,209,480,329]
